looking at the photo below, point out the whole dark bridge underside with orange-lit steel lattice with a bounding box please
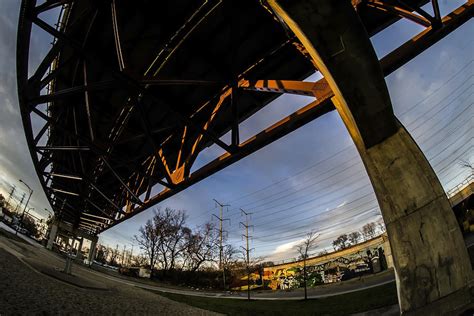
[17,0,473,234]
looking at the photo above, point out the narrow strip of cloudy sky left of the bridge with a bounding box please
[0,0,54,220]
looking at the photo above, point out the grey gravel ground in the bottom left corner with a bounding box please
[0,236,221,315]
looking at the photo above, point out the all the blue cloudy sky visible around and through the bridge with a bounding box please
[0,0,474,261]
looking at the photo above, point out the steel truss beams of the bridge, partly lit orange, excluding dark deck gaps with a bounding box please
[17,0,473,234]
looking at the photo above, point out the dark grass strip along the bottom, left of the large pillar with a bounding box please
[152,282,397,315]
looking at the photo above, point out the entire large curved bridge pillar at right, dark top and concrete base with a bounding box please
[269,0,473,315]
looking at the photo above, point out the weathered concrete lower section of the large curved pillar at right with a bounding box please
[359,126,472,313]
